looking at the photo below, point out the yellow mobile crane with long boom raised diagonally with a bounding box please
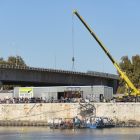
[73,10,140,99]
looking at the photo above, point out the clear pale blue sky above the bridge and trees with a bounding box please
[0,0,140,74]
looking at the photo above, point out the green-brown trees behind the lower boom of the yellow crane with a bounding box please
[118,55,140,93]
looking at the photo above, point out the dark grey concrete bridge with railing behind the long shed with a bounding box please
[0,65,119,93]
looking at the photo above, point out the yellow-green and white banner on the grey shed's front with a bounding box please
[19,87,33,98]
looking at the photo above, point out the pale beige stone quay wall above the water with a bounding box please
[0,103,140,122]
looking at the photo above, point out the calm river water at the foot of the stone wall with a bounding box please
[0,127,140,140]
